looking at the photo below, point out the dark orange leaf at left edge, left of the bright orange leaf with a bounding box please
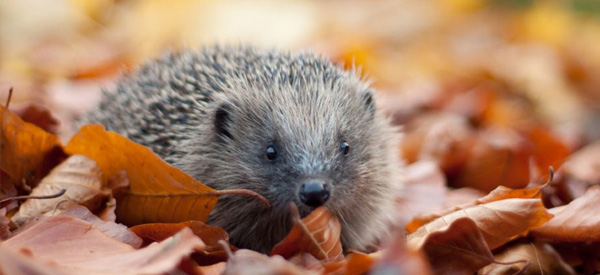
[0,106,64,194]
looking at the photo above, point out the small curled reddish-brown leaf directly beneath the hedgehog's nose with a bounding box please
[271,207,344,262]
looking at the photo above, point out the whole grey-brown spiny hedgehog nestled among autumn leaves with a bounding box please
[78,47,400,252]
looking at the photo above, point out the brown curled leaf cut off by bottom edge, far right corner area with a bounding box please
[477,243,575,275]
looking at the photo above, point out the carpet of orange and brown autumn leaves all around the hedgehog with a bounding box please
[0,0,600,274]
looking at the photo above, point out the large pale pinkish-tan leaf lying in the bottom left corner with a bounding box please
[0,216,203,274]
